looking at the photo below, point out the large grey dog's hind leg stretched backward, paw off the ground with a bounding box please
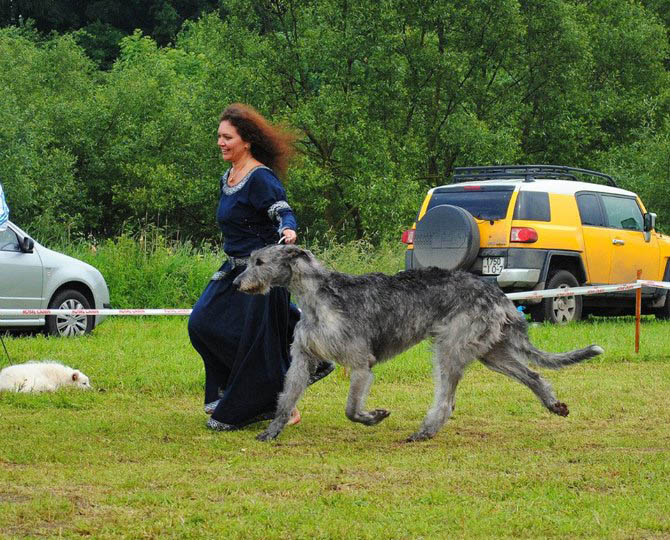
[481,342,569,416]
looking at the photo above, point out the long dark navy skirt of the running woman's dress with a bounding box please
[188,261,300,426]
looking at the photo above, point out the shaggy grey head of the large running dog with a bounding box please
[233,245,315,294]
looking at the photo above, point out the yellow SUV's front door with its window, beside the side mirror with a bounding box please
[601,193,659,283]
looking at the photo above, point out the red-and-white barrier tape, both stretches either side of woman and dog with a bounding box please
[0,279,670,316]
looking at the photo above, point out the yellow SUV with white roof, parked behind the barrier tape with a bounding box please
[403,165,670,323]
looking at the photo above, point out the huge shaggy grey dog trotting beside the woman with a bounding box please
[234,246,603,441]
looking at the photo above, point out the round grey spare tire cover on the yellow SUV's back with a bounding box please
[414,204,479,270]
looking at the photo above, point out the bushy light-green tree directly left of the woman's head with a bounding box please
[81,33,218,236]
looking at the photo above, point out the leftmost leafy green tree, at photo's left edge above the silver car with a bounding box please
[0,28,95,238]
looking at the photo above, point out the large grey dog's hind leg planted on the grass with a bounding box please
[407,344,472,442]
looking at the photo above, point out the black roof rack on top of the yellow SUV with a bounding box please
[452,165,618,187]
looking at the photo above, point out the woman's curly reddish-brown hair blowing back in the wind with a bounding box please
[219,103,297,177]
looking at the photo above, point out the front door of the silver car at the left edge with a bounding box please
[0,226,43,323]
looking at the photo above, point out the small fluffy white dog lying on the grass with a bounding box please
[0,361,91,392]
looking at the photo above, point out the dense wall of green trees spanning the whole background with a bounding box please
[0,0,670,243]
